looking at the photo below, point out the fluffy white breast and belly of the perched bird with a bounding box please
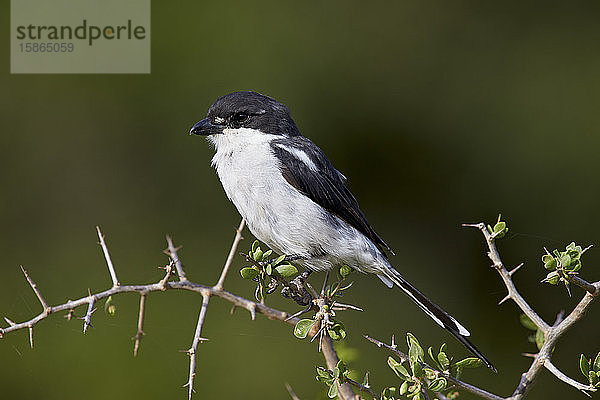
[209,128,380,270]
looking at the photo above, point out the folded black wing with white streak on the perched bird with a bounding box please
[271,136,394,254]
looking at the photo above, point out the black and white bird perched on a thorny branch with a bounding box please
[189,91,496,371]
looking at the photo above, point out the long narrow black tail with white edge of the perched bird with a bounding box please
[380,267,498,372]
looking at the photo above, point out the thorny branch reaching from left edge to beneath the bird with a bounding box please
[0,219,356,400]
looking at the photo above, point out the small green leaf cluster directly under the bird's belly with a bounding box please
[240,240,298,301]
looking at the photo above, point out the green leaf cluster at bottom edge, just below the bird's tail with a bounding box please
[382,333,483,400]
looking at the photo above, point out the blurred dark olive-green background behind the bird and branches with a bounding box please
[0,1,600,400]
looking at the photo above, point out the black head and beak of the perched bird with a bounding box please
[190,92,300,136]
